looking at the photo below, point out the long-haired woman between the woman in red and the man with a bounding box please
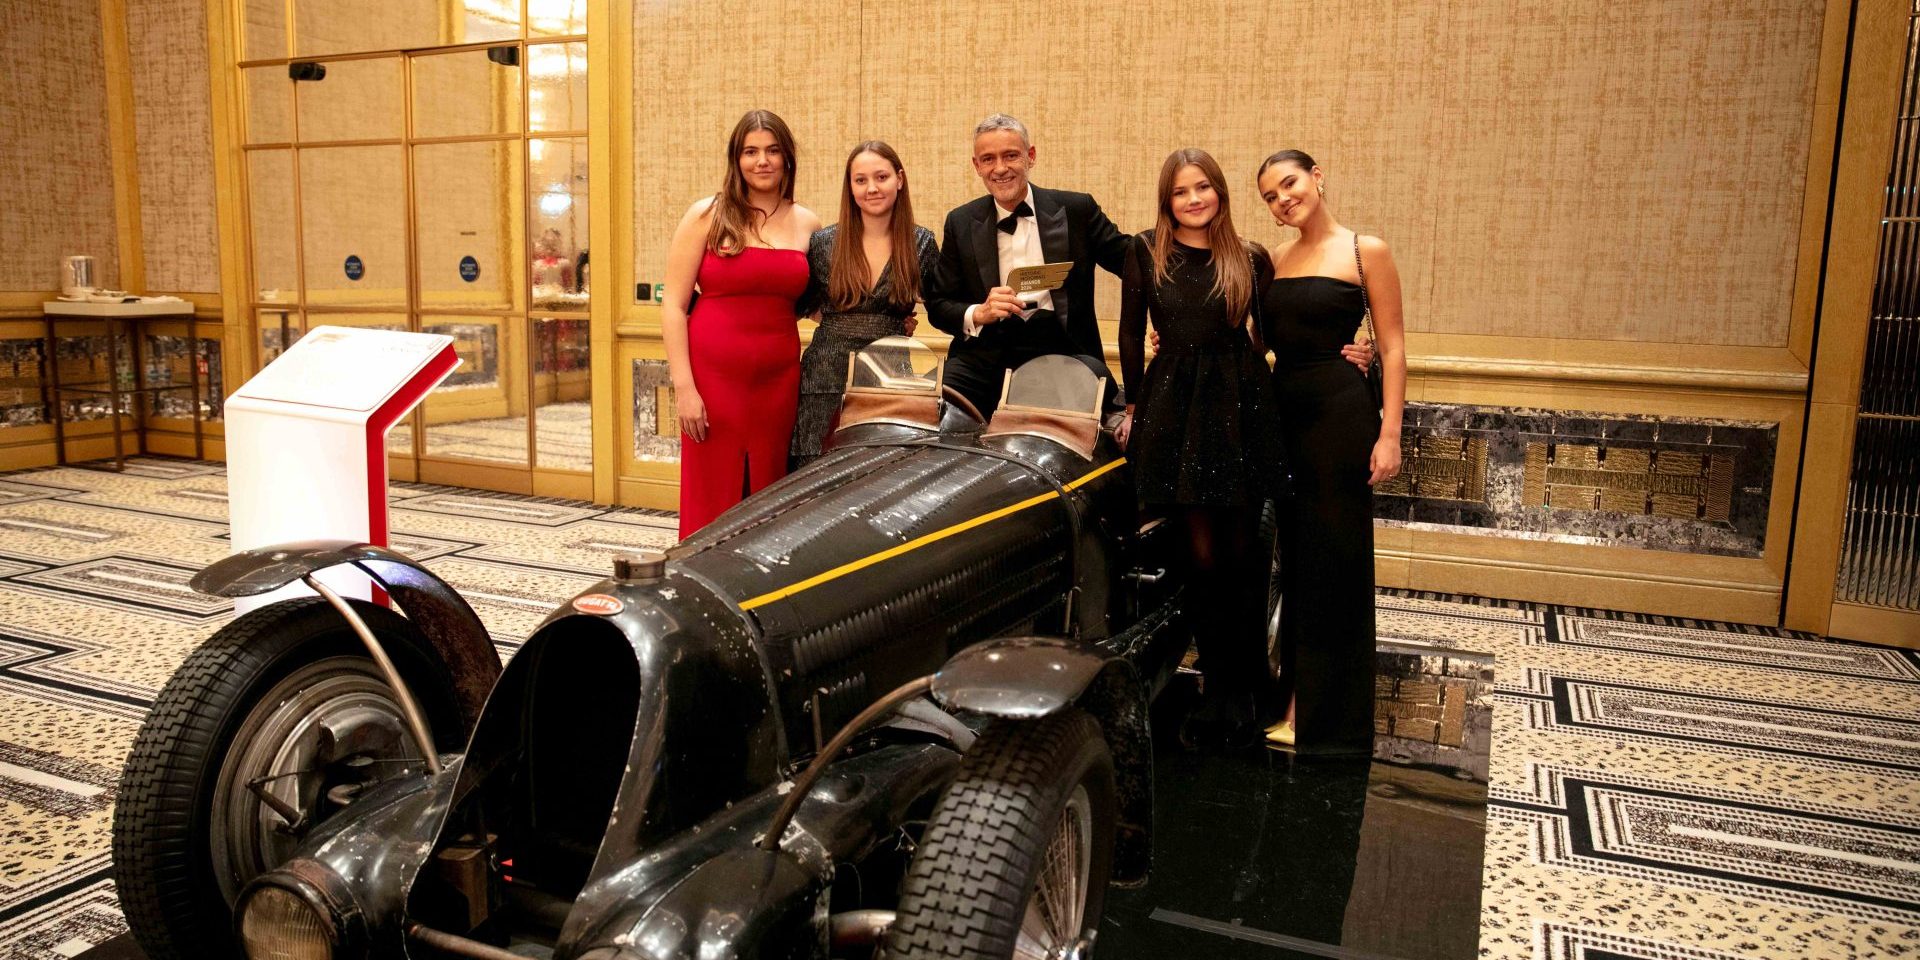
[789,140,941,468]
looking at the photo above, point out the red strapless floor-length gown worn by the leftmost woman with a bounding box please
[680,246,806,540]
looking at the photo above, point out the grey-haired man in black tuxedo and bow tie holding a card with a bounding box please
[925,113,1129,417]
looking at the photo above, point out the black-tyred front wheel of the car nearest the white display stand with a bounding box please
[113,597,465,960]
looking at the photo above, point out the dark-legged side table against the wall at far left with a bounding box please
[40,300,205,470]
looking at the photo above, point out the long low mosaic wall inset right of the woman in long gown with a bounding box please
[1373,403,1780,557]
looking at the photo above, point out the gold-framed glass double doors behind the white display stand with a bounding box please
[240,0,593,499]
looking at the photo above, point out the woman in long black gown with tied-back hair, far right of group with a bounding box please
[1256,150,1405,753]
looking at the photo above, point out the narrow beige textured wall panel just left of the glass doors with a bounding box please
[127,0,221,294]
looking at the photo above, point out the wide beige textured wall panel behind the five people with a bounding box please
[634,0,1822,346]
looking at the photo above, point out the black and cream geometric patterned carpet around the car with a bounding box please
[0,459,1920,960]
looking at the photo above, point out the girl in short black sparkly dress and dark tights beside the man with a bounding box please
[1117,148,1281,743]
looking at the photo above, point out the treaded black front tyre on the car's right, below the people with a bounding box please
[887,710,1116,960]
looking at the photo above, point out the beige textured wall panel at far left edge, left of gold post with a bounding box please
[0,0,119,290]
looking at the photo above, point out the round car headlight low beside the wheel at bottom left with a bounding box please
[238,858,365,960]
